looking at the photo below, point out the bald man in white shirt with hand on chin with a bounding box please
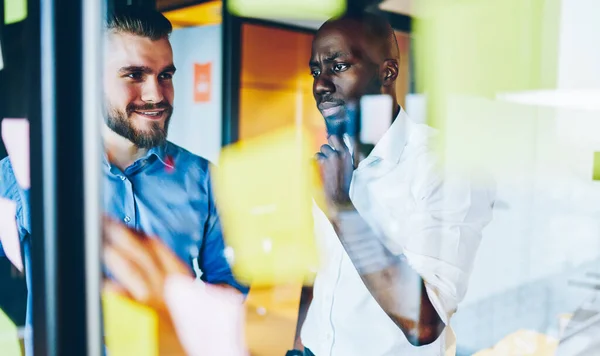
[297,14,493,356]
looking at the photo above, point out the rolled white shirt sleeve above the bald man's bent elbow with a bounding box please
[403,154,494,325]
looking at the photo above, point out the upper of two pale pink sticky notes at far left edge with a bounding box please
[2,119,31,189]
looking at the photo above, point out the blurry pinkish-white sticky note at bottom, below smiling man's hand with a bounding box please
[165,276,248,356]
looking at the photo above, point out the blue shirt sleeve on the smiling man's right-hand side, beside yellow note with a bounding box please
[198,173,249,294]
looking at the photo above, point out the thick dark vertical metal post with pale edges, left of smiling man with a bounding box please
[29,0,104,356]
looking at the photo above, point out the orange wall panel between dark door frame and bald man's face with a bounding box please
[239,24,324,145]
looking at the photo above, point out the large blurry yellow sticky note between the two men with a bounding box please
[213,127,319,287]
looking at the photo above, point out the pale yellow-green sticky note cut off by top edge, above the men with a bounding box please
[227,0,346,21]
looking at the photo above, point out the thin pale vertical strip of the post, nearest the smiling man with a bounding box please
[81,0,106,356]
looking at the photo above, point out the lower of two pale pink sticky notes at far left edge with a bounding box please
[0,198,23,272]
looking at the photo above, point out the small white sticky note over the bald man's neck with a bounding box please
[360,95,393,145]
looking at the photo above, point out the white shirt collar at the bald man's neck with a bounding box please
[364,108,411,163]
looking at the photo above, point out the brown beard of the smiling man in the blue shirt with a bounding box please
[105,102,173,148]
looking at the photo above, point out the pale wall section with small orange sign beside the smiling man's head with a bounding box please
[169,25,222,162]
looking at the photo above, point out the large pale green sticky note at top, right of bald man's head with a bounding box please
[412,0,561,145]
